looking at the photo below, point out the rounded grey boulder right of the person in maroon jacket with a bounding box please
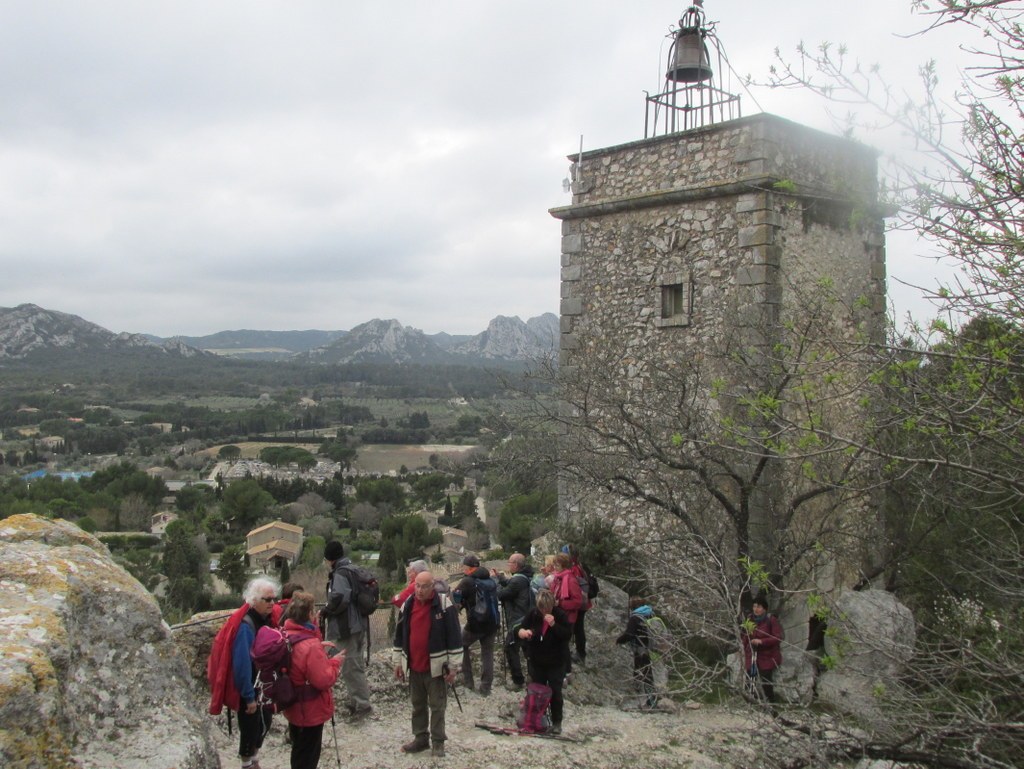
[817,590,916,725]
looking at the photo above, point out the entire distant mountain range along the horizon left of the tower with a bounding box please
[0,304,558,366]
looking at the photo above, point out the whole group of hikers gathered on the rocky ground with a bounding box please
[207,541,781,769]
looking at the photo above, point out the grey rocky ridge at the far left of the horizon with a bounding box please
[0,304,203,360]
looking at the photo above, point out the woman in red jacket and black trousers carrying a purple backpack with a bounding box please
[284,592,345,769]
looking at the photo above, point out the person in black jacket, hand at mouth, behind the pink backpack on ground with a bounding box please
[518,590,572,734]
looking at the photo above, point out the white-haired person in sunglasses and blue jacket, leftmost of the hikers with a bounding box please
[231,576,278,769]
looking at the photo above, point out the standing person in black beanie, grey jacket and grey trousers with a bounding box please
[324,540,374,718]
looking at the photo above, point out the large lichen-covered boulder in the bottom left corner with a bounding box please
[0,515,220,769]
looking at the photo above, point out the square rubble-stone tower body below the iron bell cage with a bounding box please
[551,9,885,610]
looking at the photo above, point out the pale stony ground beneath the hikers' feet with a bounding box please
[214,684,770,769]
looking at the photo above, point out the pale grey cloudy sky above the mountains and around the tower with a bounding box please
[0,0,970,336]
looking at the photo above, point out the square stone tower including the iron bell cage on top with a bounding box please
[550,1,885,606]
